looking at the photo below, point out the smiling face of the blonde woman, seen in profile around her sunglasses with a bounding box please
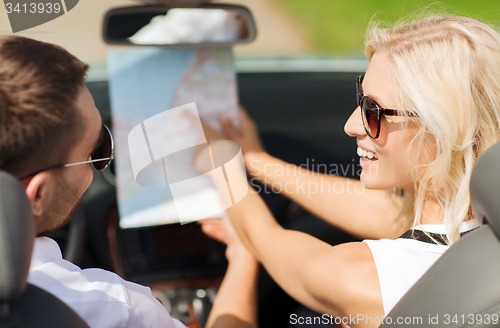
[344,53,418,193]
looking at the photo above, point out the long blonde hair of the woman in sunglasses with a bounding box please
[365,16,500,243]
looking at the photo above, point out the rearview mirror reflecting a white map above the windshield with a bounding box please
[103,4,256,47]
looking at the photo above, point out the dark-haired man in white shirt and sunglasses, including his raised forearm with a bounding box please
[0,36,257,327]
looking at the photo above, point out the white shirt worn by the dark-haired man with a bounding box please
[28,237,185,328]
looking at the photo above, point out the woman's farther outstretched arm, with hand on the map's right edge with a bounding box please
[217,109,408,239]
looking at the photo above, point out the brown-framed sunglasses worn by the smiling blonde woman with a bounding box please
[356,75,418,139]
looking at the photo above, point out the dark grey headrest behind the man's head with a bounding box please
[0,171,35,301]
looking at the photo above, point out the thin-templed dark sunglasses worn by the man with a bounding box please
[19,124,115,180]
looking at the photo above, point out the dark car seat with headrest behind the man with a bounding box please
[0,171,89,328]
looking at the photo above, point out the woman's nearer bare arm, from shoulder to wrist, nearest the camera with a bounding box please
[227,187,383,326]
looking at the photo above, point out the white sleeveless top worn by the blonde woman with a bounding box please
[363,220,479,316]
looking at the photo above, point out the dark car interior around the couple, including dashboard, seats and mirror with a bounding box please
[0,1,500,327]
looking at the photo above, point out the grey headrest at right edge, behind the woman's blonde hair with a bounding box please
[470,143,500,239]
